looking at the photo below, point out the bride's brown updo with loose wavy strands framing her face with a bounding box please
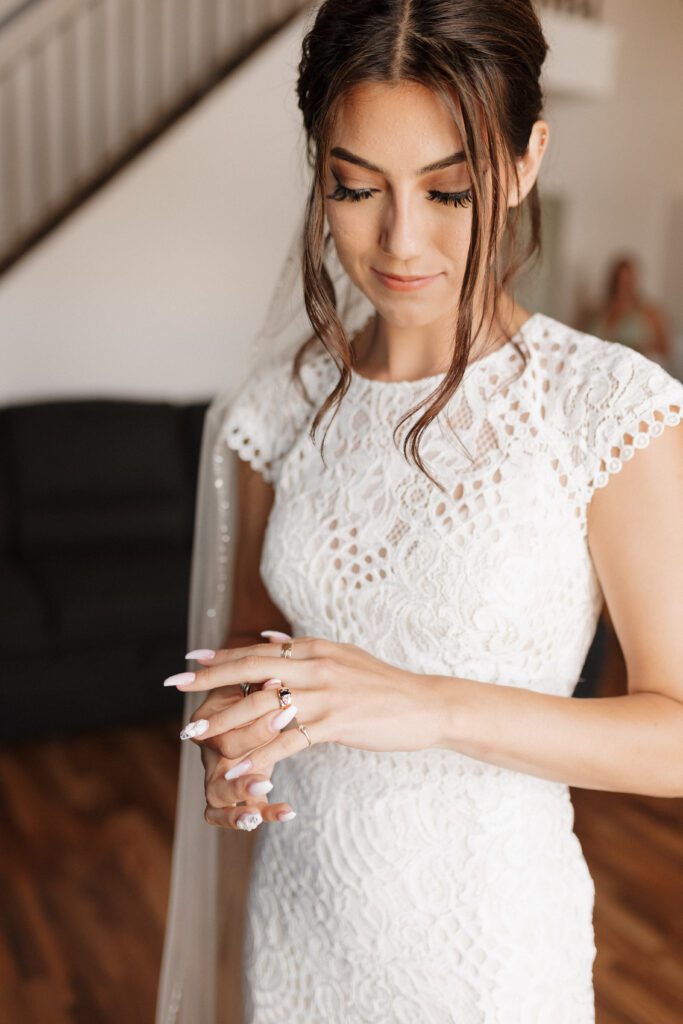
[293,0,548,489]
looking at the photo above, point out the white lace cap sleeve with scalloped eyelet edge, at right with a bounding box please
[571,339,683,502]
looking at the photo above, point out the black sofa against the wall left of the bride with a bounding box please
[0,398,209,742]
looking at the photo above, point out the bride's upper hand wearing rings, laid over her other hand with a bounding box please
[169,637,444,773]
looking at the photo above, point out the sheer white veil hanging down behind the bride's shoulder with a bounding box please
[155,203,374,1024]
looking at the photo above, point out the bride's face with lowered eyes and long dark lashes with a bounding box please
[325,82,472,327]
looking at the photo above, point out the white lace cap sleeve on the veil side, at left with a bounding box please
[222,353,310,483]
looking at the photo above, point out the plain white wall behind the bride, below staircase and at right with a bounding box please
[0,0,683,403]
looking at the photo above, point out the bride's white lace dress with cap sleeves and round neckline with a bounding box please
[224,313,683,1024]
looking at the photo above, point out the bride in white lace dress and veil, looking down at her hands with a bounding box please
[157,0,683,1024]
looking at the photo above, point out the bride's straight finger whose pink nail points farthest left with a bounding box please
[164,640,329,693]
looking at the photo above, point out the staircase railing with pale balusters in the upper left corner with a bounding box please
[0,0,307,273]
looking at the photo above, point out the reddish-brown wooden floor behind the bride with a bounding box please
[0,626,683,1024]
